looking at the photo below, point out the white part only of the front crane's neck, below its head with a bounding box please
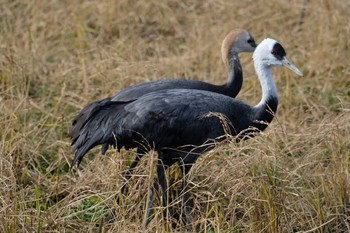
[254,57,278,106]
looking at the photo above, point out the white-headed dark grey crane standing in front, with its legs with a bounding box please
[72,39,302,225]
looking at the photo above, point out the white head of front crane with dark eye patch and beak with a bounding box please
[253,38,303,76]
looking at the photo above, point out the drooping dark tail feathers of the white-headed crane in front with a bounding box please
[72,99,133,167]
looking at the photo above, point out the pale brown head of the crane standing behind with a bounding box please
[221,29,257,66]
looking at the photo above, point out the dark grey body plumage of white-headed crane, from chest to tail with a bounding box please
[74,89,277,167]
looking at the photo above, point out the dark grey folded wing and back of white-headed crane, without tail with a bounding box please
[110,89,251,152]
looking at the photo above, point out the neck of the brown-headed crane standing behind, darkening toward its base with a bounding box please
[224,51,243,98]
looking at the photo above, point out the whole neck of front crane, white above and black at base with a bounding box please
[254,59,278,130]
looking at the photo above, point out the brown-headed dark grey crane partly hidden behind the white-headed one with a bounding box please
[70,29,257,153]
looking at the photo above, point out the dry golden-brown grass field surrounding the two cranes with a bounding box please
[0,0,350,233]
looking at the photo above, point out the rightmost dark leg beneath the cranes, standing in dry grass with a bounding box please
[180,159,193,229]
